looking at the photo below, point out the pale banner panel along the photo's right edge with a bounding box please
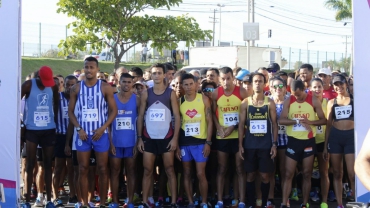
[352,0,370,202]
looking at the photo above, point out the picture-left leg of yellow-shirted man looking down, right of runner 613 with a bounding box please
[282,156,297,205]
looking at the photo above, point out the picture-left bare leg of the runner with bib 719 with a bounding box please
[77,151,91,205]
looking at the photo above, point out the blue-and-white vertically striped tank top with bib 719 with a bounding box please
[76,80,108,136]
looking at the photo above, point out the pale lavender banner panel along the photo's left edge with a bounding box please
[0,0,21,208]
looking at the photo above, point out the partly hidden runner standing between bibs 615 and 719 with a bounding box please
[53,75,77,206]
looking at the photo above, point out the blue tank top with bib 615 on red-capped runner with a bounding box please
[23,79,55,130]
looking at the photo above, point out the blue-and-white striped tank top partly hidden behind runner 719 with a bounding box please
[56,92,69,134]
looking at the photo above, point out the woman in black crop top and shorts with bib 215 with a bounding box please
[323,75,355,208]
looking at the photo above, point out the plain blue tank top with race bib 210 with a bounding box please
[112,93,137,147]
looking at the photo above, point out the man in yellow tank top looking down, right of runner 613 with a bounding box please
[278,80,326,208]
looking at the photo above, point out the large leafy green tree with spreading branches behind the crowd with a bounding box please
[57,0,212,68]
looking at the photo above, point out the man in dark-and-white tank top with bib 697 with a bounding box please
[137,64,181,207]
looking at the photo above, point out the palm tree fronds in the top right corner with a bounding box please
[325,0,352,21]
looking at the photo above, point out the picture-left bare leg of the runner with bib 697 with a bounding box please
[142,152,156,203]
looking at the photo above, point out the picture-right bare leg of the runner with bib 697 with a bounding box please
[162,152,177,203]
